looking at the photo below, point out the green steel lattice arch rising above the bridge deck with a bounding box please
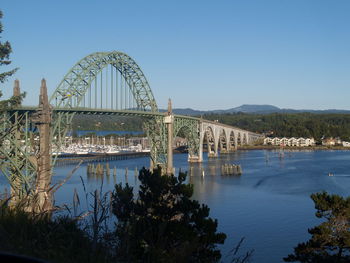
[50,51,158,112]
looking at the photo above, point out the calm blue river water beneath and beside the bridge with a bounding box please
[4,150,350,263]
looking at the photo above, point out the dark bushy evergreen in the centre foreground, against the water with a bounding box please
[113,169,226,262]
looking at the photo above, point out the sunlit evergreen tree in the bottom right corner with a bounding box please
[284,192,350,263]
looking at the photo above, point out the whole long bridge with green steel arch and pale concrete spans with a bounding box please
[0,51,262,196]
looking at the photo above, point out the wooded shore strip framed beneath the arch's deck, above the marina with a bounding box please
[72,115,144,131]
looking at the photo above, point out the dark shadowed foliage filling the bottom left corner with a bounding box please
[0,204,112,263]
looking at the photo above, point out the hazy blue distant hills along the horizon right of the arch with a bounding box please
[160,104,350,116]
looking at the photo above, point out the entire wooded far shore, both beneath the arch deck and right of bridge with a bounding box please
[72,113,350,141]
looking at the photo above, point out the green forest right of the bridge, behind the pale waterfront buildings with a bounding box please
[203,113,350,141]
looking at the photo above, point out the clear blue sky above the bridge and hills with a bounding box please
[0,0,350,110]
